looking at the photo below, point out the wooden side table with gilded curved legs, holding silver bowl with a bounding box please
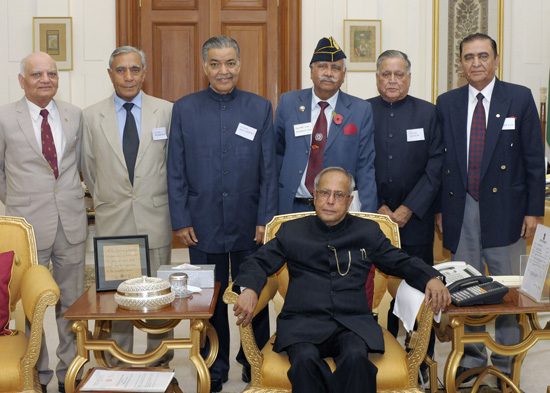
[63,283,220,393]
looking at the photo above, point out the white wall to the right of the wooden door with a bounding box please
[302,0,550,152]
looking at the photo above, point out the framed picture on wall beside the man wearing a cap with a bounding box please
[344,19,382,72]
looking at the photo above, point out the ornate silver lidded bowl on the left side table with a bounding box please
[115,276,174,311]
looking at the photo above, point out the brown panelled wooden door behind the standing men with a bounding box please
[117,0,301,108]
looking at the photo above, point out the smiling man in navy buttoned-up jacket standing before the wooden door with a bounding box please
[167,36,277,392]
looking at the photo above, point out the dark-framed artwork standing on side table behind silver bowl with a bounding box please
[94,235,151,292]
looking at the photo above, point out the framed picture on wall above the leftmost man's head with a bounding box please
[32,17,73,71]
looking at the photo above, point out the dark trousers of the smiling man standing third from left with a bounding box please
[189,247,269,379]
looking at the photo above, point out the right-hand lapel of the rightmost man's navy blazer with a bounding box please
[480,79,512,180]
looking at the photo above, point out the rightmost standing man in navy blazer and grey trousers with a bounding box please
[436,33,545,382]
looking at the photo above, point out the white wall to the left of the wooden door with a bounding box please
[0,0,116,108]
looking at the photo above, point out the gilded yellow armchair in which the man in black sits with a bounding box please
[223,213,433,393]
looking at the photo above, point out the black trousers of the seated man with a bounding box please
[285,325,378,393]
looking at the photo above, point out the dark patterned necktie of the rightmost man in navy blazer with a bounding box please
[468,93,486,201]
